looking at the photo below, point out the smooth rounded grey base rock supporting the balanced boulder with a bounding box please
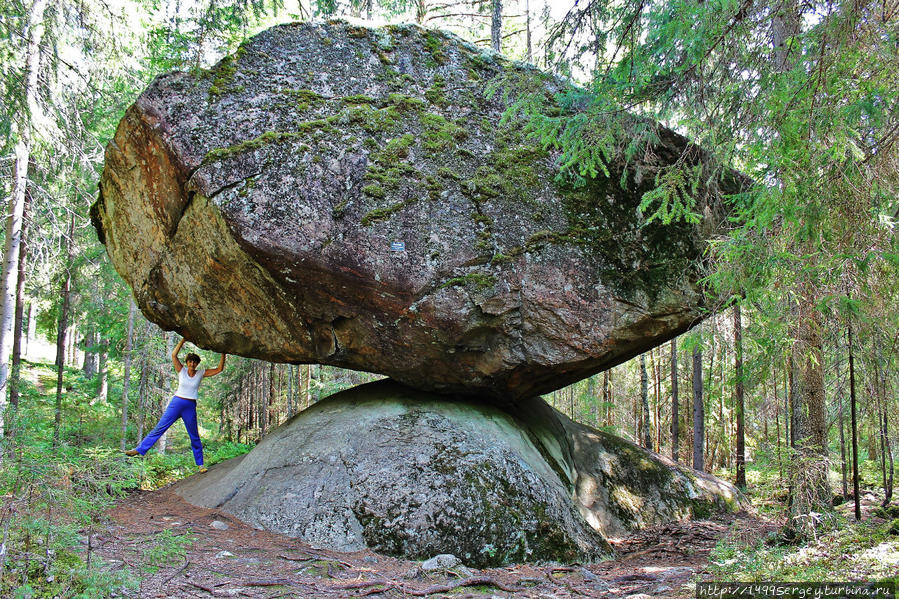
[175,380,742,567]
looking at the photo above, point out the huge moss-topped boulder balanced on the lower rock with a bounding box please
[93,22,735,400]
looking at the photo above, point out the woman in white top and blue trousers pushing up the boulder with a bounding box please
[125,337,225,472]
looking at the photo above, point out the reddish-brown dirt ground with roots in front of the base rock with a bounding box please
[91,488,773,599]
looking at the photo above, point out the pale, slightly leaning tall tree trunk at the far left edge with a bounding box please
[0,0,48,437]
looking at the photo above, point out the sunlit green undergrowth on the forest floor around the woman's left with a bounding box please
[0,362,251,599]
